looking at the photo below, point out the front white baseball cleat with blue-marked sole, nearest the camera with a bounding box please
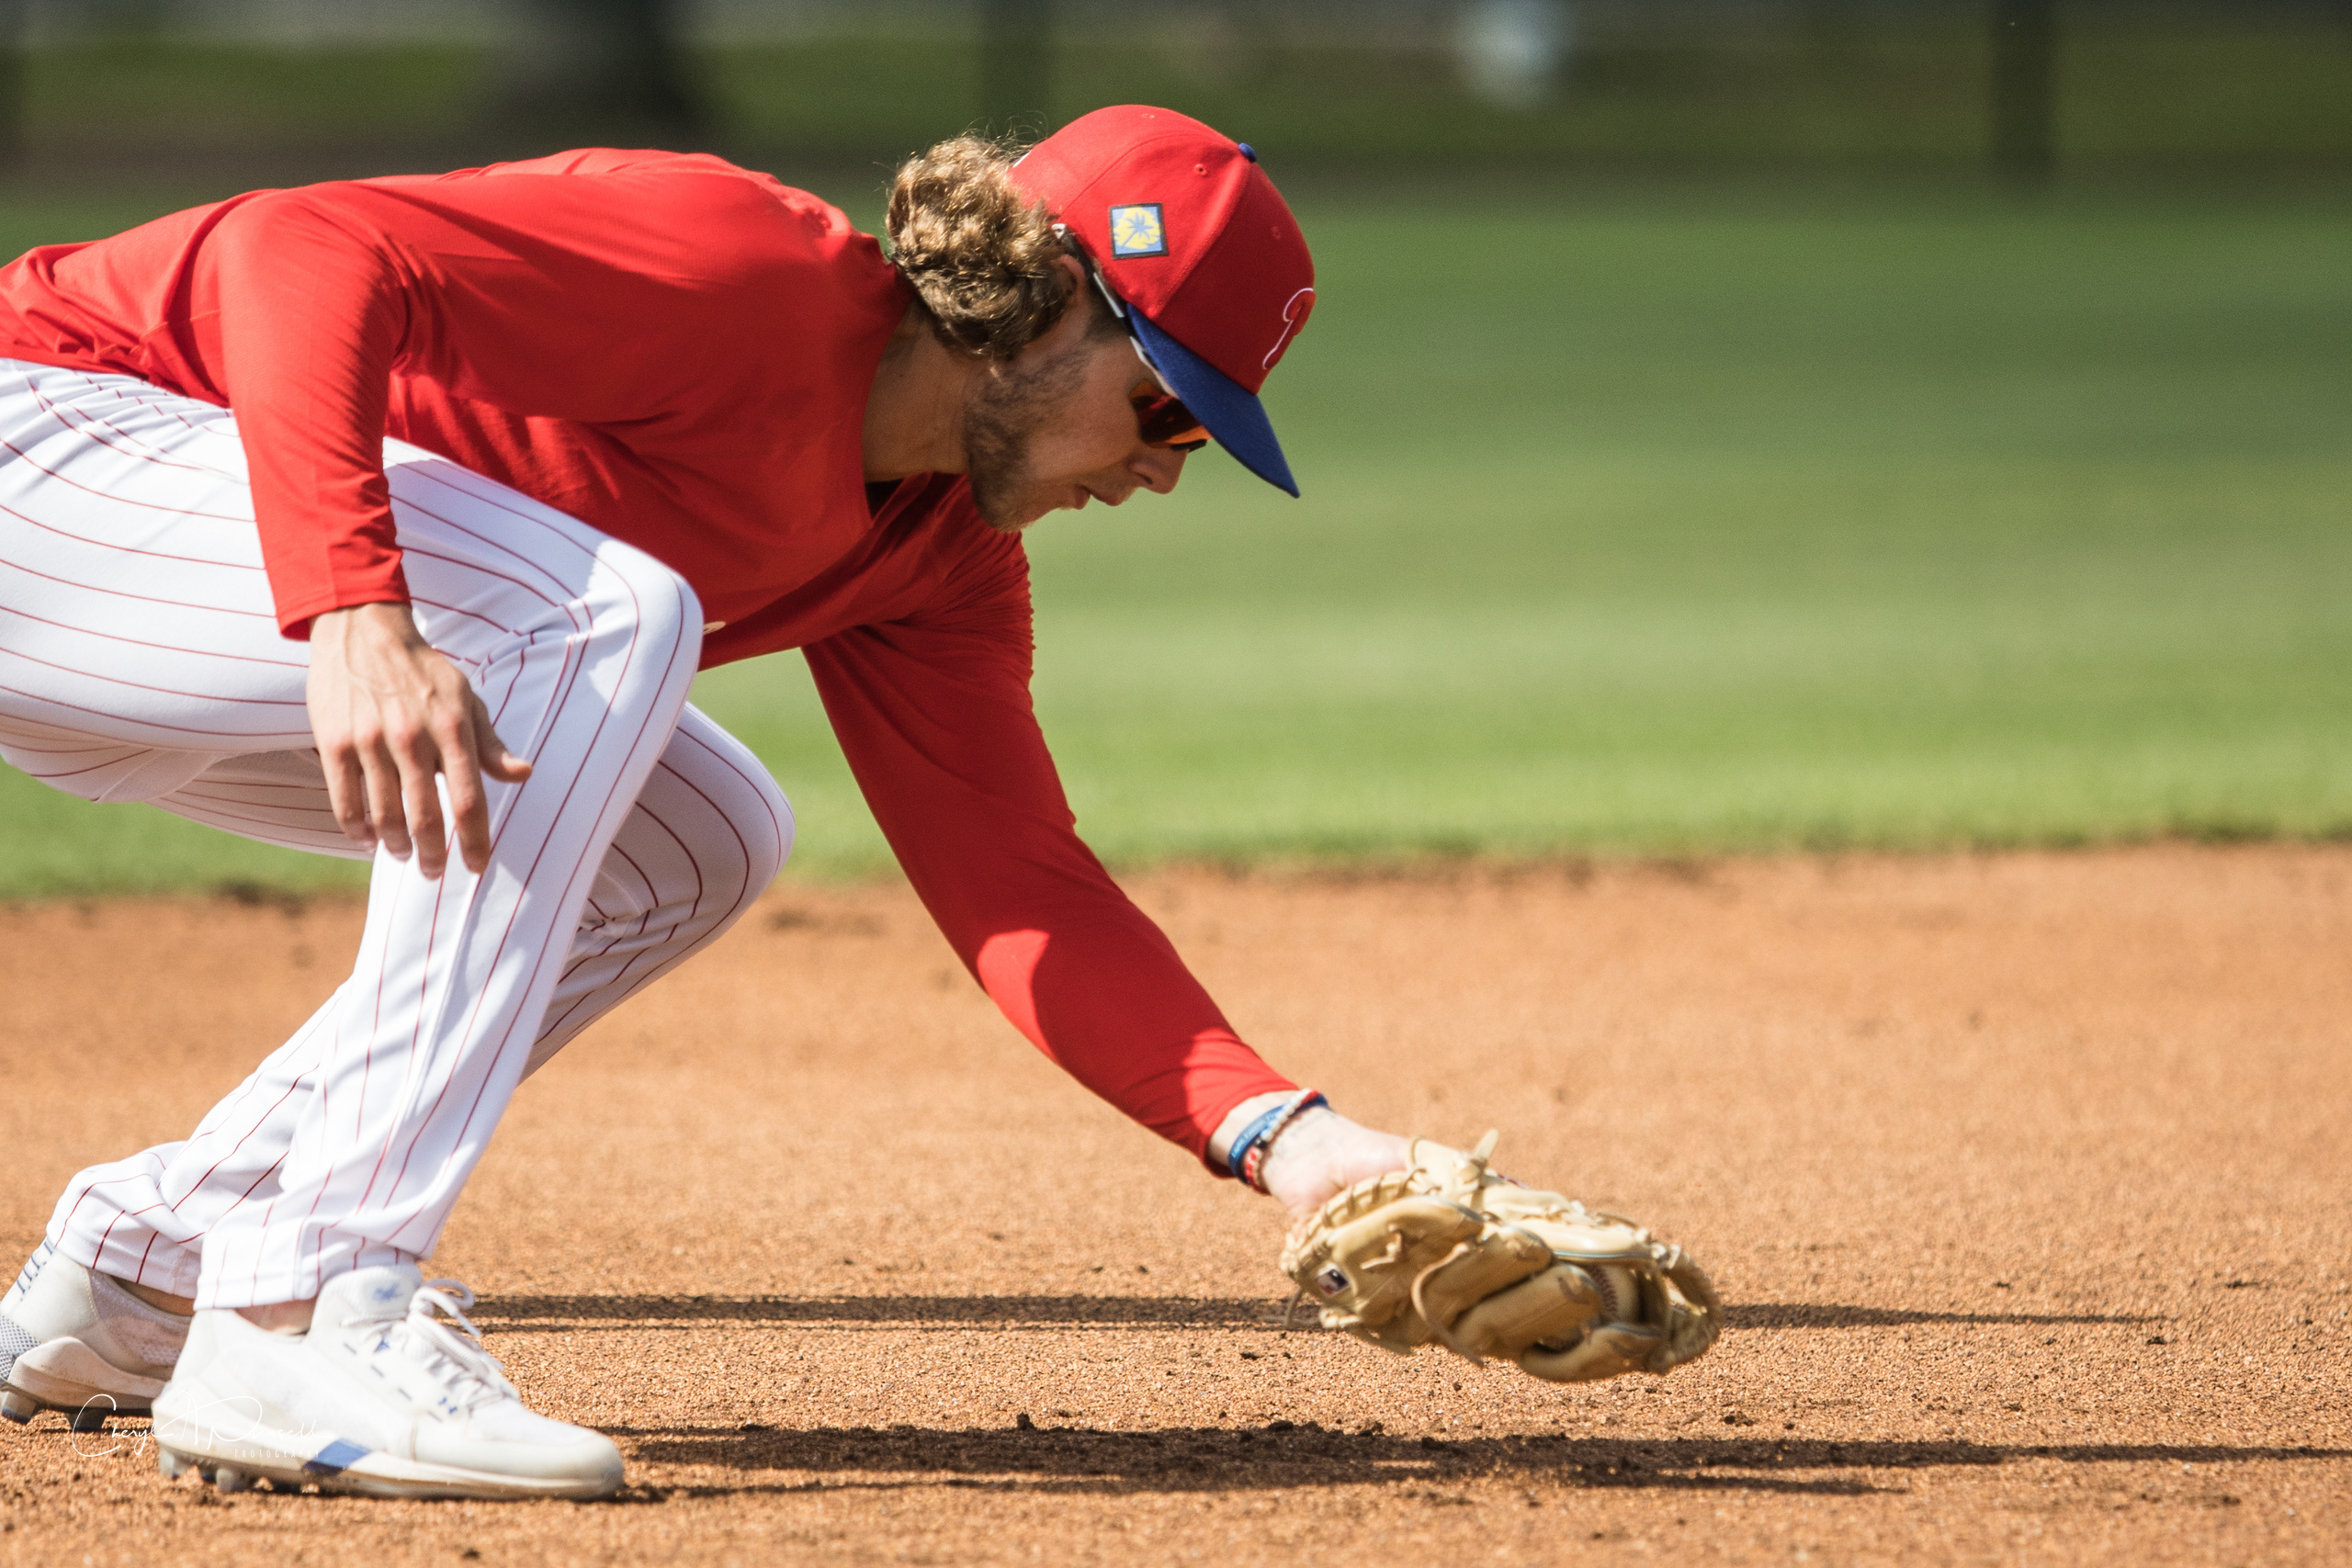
[155,1265,621,1497]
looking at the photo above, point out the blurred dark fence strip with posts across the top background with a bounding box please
[0,0,2352,179]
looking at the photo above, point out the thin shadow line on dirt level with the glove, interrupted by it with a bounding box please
[473,1295,2166,1333]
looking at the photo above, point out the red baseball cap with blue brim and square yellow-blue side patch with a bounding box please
[1013,104,1315,496]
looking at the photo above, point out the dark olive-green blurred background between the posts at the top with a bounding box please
[21,19,2352,176]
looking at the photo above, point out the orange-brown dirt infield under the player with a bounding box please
[0,849,2352,1565]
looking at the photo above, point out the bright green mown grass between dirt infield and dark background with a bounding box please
[0,186,2352,894]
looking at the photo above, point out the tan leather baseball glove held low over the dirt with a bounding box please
[1282,1134,1724,1382]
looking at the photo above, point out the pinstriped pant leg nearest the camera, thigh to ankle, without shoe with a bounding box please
[195,445,701,1307]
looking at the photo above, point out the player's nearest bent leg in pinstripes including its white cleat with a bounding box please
[153,458,701,1497]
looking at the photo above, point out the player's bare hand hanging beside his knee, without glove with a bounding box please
[311,604,532,877]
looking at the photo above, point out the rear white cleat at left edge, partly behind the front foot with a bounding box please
[0,1241,188,1432]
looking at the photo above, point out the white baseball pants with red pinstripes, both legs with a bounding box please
[0,360,793,1307]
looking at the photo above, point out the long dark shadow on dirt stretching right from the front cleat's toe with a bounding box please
[606,1422,2352,1495]
